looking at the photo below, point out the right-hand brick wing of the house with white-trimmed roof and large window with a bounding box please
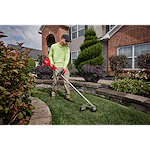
[100,23,150,76]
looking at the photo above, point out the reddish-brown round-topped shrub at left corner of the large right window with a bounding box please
[109,55,128,76]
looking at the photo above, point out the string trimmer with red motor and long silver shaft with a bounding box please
[42,55,97,112]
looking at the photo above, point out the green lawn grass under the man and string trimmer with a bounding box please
[32,88,150,126]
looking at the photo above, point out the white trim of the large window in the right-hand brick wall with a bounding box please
[117,42,150,70]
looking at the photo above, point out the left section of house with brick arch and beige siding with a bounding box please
[38,22,115,74]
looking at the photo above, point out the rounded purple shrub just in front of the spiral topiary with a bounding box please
[81,65,105,83]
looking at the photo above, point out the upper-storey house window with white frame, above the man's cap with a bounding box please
[71,22,85,39]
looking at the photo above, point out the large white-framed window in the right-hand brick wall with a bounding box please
[118,43,150,69]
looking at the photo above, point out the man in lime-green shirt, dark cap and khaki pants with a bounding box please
[48,34,74,102]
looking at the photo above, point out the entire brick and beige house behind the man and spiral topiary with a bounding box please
[39,22,150,76]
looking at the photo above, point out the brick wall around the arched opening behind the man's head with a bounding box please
[42,24,68,56]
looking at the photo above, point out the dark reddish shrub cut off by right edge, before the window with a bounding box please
[137,54,150,81]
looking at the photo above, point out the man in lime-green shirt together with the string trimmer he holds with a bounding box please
[42,35,97,112]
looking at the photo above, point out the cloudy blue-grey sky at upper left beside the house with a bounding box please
[0,22,42,50]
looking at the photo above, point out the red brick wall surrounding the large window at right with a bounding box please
[108,24,150,76]
